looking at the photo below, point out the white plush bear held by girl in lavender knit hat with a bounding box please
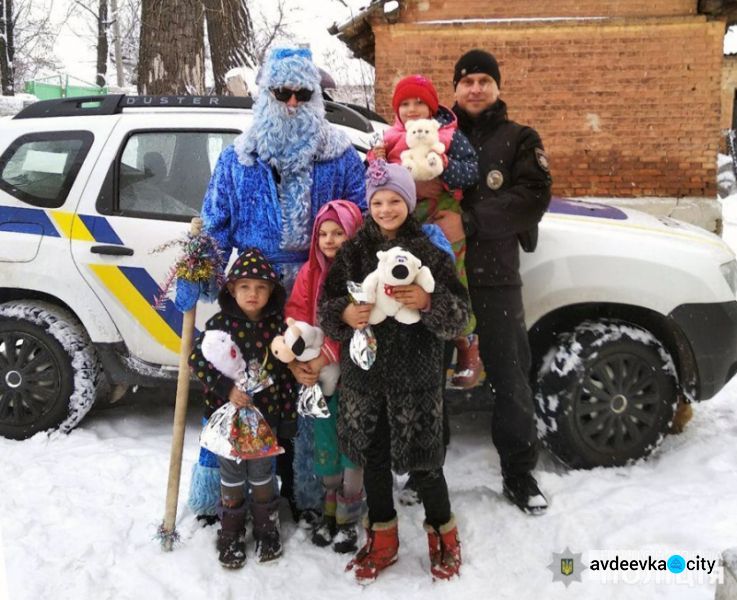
[362,246,435,325]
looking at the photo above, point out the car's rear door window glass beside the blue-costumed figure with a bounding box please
[115,130,240,221]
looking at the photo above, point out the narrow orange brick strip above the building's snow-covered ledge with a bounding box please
[401,0,697,23]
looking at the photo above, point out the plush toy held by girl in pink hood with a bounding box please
[271,317,340,396]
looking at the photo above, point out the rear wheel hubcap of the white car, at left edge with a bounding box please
[0,332,61,425]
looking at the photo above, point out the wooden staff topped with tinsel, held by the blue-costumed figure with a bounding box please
[154,218,224,551]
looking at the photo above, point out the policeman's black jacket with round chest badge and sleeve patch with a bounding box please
[453,100,552,287]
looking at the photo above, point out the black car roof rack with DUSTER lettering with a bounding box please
[13,94,374,133]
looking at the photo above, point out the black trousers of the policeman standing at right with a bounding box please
[469,286,538,476]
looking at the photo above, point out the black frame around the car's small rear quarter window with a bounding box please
[0,129,95,208]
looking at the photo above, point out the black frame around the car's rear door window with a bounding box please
[95,127,243,223]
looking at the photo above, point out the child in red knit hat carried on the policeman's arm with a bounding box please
[367,75,481,388]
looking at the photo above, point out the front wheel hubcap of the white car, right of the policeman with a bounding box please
[574,353,660,453]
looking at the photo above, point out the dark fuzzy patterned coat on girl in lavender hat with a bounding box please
[319,217,469,472]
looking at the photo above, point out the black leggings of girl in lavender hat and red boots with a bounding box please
[363,408,450,528]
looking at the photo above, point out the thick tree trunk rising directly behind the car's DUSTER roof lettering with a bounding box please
[138,0,205,95]
